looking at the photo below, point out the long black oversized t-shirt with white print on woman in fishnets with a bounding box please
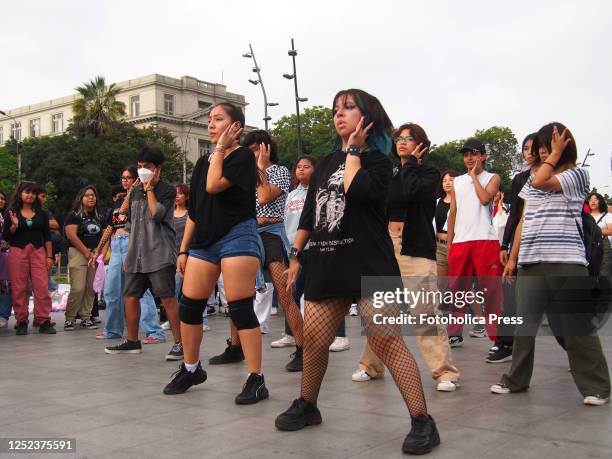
[299,150,400,301]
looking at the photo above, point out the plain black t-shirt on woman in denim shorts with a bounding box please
[189,147,256,249]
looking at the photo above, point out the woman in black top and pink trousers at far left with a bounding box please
[3,182,55,335]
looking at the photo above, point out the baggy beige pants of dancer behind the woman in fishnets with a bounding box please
[359,232,460,381]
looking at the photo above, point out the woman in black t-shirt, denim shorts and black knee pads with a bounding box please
[164,103,268,405]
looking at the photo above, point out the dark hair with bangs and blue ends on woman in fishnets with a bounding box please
[332,89,393,155]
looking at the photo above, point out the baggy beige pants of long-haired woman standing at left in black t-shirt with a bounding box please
[66,247,96,322]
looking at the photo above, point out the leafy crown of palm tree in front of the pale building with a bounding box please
[72,76,125,137]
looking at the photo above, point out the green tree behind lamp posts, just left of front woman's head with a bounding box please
[270,105,336,167]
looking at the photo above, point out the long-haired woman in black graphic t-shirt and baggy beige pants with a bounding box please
[64,185,102,330]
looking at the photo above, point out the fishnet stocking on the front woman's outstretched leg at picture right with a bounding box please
[357,298,427,417]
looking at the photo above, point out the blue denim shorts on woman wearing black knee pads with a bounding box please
[189,218,263,265]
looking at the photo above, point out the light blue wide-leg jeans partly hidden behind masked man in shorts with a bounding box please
[104,234,166,341]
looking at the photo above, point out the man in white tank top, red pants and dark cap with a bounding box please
[448,139,503,358]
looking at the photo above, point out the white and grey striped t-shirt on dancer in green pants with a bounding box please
[518,168,589,266]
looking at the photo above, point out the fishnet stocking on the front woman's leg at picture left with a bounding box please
[301,298,351,403]
